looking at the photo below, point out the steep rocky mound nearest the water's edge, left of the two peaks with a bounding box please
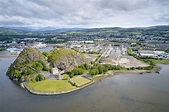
[7,47,46,81]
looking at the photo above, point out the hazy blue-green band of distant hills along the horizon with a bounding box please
[0,25,169,36]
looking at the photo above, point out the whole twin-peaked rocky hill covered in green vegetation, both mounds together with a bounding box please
[7,48,87,82]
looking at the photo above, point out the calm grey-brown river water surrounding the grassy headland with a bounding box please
[0,58,169,112]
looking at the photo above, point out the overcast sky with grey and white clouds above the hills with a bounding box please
[0,0,169,28]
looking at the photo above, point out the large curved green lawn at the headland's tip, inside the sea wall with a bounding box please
[27,80,75,92]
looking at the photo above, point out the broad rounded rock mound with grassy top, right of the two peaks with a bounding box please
[48,49,88,71]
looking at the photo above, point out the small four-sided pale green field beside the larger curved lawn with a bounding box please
[71,76,91,86]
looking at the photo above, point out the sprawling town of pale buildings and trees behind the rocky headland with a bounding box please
[0,26,169,59]
